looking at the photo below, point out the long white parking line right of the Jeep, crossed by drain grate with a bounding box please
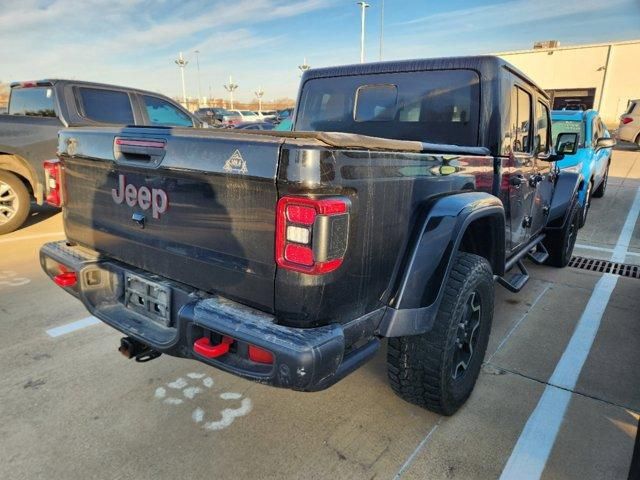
[500,188,640,480]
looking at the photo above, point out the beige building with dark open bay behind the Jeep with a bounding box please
[496,40,640,127]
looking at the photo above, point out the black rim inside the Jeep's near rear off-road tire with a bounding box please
[451,291,482,380]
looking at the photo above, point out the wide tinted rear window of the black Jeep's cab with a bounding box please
[295,70,480,146]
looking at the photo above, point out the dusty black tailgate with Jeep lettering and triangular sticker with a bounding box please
[58,127,281,311]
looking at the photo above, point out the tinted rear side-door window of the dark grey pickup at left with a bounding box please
[77,87,135,125]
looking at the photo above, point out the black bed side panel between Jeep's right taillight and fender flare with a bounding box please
[275,145,494,326]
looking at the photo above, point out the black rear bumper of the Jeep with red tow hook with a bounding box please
[40,242,382,391]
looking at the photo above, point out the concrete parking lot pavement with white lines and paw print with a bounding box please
[0,151,640,480]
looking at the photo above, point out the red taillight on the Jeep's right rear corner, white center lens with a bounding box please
[276,197,349,275]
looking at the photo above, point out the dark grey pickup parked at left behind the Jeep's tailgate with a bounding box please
[0,80,202,234]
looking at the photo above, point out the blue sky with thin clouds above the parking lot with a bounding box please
[0,0,640,100]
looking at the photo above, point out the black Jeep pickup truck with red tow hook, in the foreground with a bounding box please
[40,57,580,415]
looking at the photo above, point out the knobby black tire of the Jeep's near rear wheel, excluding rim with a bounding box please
[387,252,494,415]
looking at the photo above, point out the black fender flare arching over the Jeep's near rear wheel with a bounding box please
[378,192,505,337]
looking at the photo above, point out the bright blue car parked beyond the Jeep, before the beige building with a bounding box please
[551,110,611,227]
